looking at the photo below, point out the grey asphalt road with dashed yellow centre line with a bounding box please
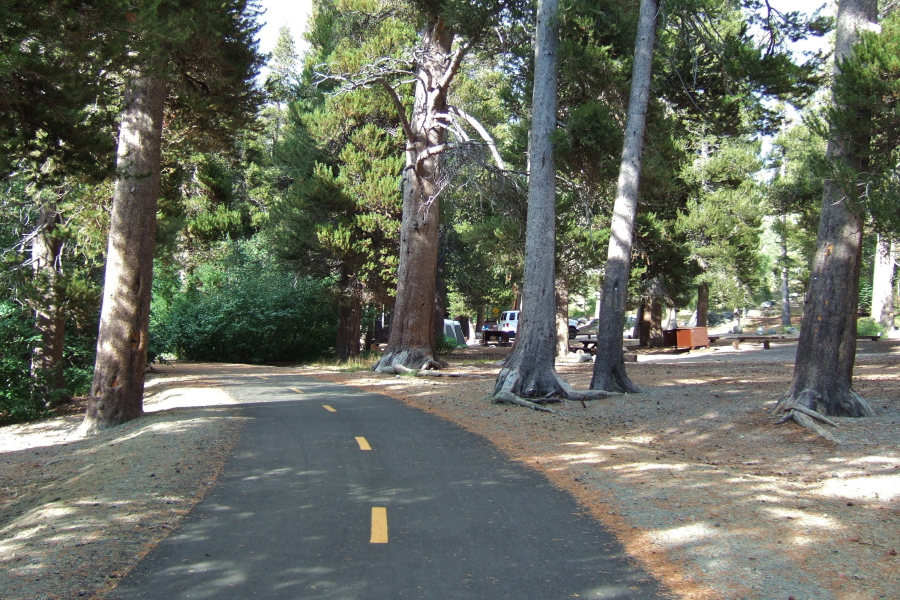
[109,376,662,600]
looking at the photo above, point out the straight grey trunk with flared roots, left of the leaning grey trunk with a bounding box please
[494,0,573,398]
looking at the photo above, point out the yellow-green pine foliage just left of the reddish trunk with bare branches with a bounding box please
[269,0,415,302]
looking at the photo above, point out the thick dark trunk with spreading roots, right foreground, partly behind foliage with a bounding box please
[775,0,878,417]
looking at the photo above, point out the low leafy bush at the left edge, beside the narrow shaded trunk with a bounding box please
[0,302,47,424]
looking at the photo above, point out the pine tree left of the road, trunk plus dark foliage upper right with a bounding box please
[80,0,260,433]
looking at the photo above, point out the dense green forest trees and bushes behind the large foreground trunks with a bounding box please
[0,0,898,422]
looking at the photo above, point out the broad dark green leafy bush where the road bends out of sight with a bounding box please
[151,241,337,363]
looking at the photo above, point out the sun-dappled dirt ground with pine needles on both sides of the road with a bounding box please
[0,340,900,600]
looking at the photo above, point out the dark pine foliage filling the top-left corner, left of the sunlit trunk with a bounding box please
[0,0,125,181]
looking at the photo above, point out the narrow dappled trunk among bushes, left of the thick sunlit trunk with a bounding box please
[31,207,67,403]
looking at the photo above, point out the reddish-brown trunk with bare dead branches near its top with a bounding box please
[373,19,458,371]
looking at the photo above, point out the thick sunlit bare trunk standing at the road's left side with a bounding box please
[80,76,166,433]
